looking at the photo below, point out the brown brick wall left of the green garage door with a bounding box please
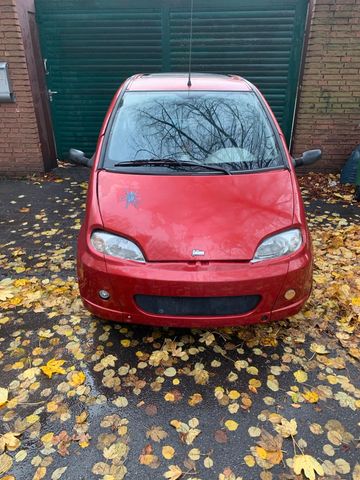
[0,0,44,175]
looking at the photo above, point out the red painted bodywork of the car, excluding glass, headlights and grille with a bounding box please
[78,76,312,327]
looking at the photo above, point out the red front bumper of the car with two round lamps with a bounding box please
[78,236,312,327]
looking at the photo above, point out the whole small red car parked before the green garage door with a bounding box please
[70,74,321,327]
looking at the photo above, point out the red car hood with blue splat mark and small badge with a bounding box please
[98,170,293,261]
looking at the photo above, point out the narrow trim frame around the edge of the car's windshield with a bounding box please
[97,90,290,175]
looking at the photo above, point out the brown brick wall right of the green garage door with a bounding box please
[292,0,360,171]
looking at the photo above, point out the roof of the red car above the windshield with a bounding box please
[127,73,252,92]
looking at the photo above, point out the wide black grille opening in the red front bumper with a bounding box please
[134,295,261,317]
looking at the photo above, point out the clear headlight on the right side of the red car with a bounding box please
[252,228,302,262]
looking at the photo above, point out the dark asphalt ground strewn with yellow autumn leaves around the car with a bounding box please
[0,166,360,480]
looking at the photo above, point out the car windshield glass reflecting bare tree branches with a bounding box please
[104,91,284,172]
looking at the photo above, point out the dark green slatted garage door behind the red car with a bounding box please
[36,0,308,159]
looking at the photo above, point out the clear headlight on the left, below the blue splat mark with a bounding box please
[90,230,145,263]
